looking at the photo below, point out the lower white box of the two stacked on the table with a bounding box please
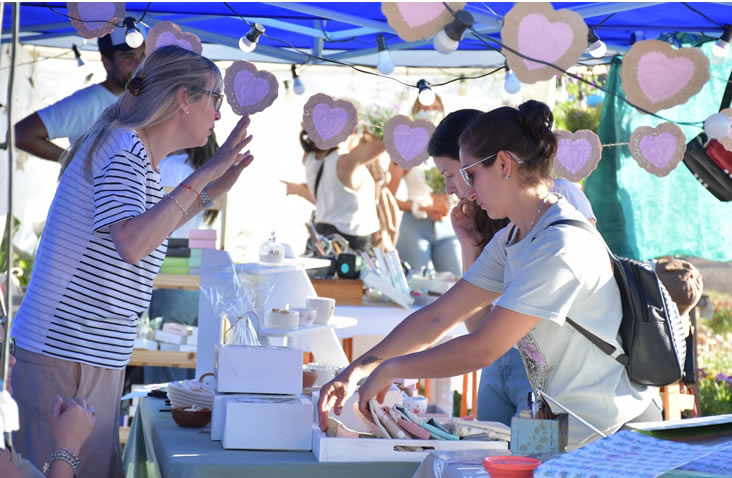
[222,395,313,451]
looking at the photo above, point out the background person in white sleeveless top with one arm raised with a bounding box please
[282,130,385,252]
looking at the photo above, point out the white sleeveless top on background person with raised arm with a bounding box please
[305,150,380,236]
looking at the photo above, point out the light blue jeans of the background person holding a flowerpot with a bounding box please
[396,212,462,277]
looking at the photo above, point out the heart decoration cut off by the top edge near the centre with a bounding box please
[381,2,466,41]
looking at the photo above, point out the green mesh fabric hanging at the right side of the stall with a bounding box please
[585,43,732,261]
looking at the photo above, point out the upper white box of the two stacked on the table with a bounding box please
[214,344,302,395]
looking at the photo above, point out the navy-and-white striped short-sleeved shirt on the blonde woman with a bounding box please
[13,129,167,369]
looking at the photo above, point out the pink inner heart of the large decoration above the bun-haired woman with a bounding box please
[518,13,574,71]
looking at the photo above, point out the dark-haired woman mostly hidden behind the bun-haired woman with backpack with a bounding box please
[428,109,595,426]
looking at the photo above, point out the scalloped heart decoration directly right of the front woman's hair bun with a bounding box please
[553,129,602,183]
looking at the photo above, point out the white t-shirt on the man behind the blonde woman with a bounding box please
[37,84,117,144]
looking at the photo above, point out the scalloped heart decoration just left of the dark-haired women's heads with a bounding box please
[384,115,435,169]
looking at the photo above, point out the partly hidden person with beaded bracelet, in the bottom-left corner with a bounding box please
[0,325,95,478]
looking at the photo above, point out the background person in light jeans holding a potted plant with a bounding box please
[388,96,461,277]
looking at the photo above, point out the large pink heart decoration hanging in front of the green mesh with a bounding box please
[620,40,709,113]
